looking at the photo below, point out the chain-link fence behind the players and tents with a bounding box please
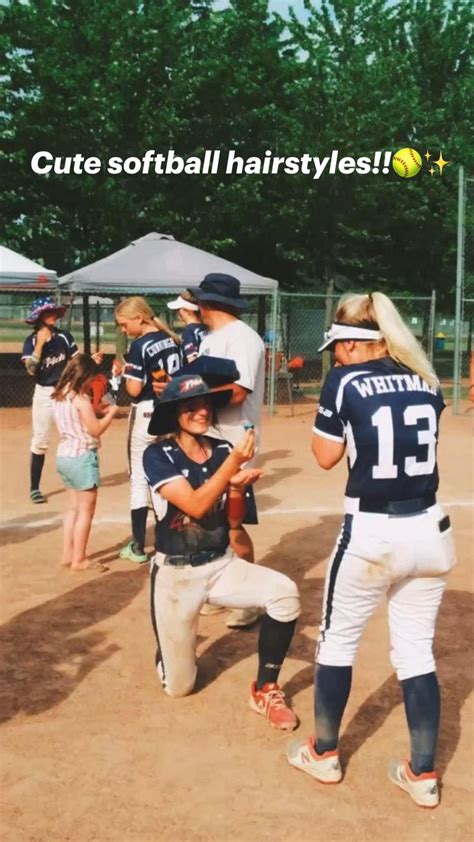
[0,292,474,412]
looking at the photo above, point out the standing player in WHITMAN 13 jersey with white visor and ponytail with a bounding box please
[288,293,455,807]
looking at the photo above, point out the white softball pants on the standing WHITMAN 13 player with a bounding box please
[316,498,455,681]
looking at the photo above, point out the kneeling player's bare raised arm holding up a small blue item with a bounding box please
[159,430,255,520]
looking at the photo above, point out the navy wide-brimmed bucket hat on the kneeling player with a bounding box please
[148,374,232,436]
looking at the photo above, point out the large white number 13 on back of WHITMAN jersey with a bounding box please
[372,404,437,479]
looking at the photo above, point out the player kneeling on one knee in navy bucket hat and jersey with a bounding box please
[143,375,300,730]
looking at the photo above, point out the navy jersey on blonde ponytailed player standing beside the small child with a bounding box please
[123,330,181,404]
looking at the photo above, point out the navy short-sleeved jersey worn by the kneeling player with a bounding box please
[143,438,232,555]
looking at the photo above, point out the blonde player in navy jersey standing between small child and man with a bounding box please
[115,296,181,564]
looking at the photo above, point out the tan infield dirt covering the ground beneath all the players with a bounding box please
[0,406,473,842]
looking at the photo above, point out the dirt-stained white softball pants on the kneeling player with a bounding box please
[151,547,300,696]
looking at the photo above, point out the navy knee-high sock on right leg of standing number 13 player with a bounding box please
[402,672,441,775]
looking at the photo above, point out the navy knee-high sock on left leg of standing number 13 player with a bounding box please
[314,664,352,754]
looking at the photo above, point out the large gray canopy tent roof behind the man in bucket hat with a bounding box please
[59,233,278,295]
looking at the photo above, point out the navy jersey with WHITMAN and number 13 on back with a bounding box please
[313,357,445,501]
